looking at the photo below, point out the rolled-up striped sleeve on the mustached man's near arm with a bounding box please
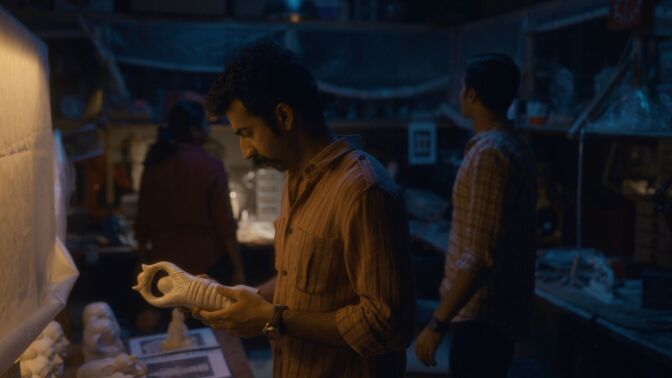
[336,185,415,357]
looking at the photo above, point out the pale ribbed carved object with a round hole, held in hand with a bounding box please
[133,261,232,311]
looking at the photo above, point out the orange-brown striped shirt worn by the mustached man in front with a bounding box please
[273,137,415,377]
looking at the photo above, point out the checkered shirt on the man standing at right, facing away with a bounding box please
[440,129,536,339]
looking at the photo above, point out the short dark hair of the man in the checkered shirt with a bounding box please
[464,54,520,114]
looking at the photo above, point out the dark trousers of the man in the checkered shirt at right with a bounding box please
[450,321,515,378]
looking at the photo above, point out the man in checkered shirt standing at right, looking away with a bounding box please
[416,54,536,378]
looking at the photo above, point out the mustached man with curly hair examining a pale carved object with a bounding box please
[194,42,415,377]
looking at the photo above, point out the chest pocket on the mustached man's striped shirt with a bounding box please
[294,227,343,294]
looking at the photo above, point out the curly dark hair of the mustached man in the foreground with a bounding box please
[206,40,326,133]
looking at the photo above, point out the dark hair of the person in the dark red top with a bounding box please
[145,101,205,166]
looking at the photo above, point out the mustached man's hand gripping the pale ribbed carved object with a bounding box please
[192,285,273,337]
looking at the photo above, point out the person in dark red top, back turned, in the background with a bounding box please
[135,101,244,284]
